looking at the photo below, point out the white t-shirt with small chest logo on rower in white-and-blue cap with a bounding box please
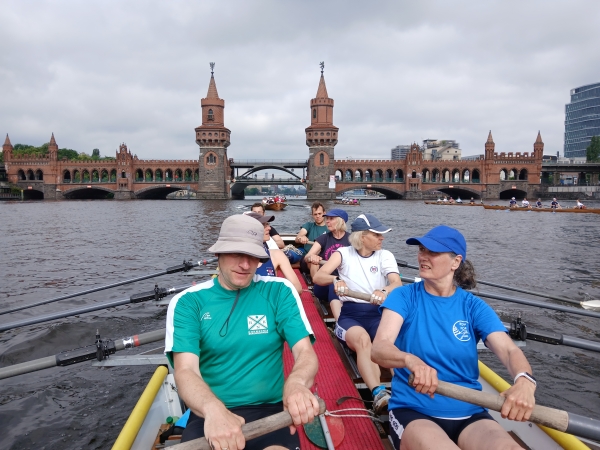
[337,246,399,303]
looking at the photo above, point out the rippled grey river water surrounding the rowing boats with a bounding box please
[0,200,600,449]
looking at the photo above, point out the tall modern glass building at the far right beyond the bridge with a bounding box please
[564,83,600,158]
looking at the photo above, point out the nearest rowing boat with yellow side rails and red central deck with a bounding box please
[108,235,587,450]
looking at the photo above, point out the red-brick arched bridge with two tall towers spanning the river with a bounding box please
[2,64,600,200]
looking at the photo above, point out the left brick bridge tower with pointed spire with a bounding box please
[196,63,231,199]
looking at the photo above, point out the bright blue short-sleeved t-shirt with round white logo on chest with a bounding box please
[380,282,506,418]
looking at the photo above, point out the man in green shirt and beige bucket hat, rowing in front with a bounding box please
[165,215,319,450]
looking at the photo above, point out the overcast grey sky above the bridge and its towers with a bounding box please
[0,0,600,159]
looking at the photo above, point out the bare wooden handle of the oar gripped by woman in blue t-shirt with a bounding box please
[408,373,569,431]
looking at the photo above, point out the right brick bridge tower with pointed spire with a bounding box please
[305,63,338,199]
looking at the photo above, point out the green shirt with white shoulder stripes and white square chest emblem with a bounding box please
[165,275,314,408]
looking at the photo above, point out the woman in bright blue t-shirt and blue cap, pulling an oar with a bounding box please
[371,225,536,449]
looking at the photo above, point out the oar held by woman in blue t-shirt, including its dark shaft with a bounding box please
[408,374,600,440]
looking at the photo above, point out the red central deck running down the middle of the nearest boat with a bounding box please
[284,269,385,450]
